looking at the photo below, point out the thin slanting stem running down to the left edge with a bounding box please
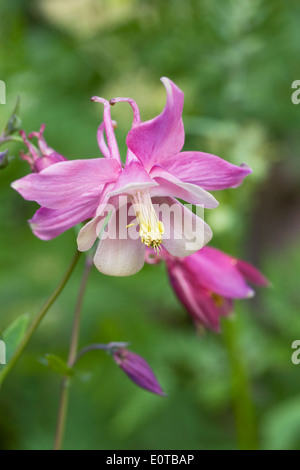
[0,251,81,388]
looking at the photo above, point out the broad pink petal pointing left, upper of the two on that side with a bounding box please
[11,158,121,209]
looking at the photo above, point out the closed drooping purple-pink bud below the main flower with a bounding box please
[113,348,165,396]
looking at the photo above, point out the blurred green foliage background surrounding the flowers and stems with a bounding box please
[0,0,300,450]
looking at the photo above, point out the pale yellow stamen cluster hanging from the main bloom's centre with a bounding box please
[132,191,165,252]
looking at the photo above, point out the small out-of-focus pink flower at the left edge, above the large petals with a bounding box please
[20,124,67,173]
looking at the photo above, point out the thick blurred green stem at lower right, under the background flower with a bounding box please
[223,316,258,450]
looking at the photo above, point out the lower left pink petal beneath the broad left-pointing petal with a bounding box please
[29,195,99,240]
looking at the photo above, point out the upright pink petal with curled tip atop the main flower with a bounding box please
[126,77,184,170]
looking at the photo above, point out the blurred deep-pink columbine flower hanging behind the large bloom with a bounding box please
[146,246,269,331]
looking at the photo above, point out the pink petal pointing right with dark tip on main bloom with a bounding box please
[164,152,252,191]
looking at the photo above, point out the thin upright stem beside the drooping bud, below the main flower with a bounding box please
[53,258,93,450]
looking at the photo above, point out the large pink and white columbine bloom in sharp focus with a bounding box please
[12,78,251,276]
